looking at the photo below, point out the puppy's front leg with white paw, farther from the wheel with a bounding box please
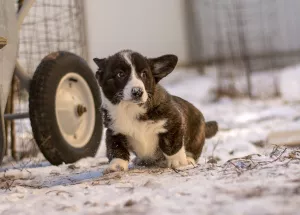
[159,133,188,168]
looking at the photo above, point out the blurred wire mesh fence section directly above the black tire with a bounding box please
[18,0,87,73]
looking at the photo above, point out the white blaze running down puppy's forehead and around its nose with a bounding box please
[123,52,148,103]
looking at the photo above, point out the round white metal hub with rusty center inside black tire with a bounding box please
[55,73,96,148]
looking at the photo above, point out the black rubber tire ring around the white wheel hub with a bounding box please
[29,51,103,165]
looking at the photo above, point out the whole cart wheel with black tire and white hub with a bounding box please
[29,51,102,165]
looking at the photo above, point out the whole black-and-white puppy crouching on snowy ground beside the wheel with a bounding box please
[94,50,218,172]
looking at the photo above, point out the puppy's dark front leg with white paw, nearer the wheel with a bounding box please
[104,129,130,173]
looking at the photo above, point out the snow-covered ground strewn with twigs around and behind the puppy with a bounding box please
[0,70,300,215]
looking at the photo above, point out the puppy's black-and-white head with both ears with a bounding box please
[94,50,178,104]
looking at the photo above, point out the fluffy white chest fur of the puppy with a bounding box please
[104,101,167,158]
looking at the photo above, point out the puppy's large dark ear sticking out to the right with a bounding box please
[149,54,178,83]
